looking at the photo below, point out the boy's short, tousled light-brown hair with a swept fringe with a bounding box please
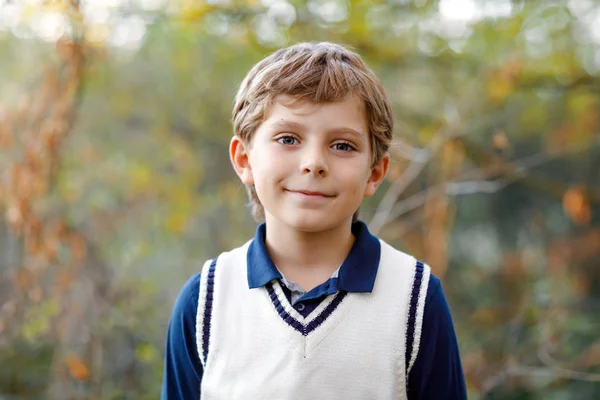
[232,42,393,221]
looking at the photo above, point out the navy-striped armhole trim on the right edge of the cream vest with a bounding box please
[406,260,431,377]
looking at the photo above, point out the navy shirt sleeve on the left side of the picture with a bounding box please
[161,274,202,400]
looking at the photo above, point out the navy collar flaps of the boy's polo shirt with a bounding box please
[246,221,381,293]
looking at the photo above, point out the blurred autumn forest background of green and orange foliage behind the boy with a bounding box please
[0,0,600,400]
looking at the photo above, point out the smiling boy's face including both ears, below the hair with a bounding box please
[230,96,389,232]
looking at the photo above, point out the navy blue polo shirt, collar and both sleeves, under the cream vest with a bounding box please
[162,221,467,400]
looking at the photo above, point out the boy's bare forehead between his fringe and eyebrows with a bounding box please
[264,95,368,134]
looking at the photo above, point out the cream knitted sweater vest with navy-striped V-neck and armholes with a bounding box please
[196,240,430,400]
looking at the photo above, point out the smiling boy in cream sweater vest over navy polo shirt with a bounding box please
[162,43,466,400]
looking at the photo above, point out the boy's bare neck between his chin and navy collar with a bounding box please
[265,216,354,290]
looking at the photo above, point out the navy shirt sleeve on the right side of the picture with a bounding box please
[408,274,467,400]
